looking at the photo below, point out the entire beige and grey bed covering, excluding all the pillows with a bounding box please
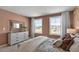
[19,36,64,52]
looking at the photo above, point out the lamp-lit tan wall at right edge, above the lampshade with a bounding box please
[70,7,79,29]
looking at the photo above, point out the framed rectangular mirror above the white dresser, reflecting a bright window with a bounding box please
[10,20,27,32]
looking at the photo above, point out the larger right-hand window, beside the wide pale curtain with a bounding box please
[49,16,61,35]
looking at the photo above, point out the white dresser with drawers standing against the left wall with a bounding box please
[8,32,29,45]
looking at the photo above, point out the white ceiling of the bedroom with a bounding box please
[0,6,74,17]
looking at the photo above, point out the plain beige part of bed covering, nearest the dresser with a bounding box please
[19,36,48,52]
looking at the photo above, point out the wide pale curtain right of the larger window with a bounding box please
[61,12,70,37]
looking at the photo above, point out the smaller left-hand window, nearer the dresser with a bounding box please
[34,19,42,33]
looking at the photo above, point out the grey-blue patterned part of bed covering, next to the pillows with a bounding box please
[35,40,64,52]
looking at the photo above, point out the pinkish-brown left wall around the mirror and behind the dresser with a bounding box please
[0,9,29,45]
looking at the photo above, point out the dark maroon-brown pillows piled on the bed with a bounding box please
[60,33,74,51]
